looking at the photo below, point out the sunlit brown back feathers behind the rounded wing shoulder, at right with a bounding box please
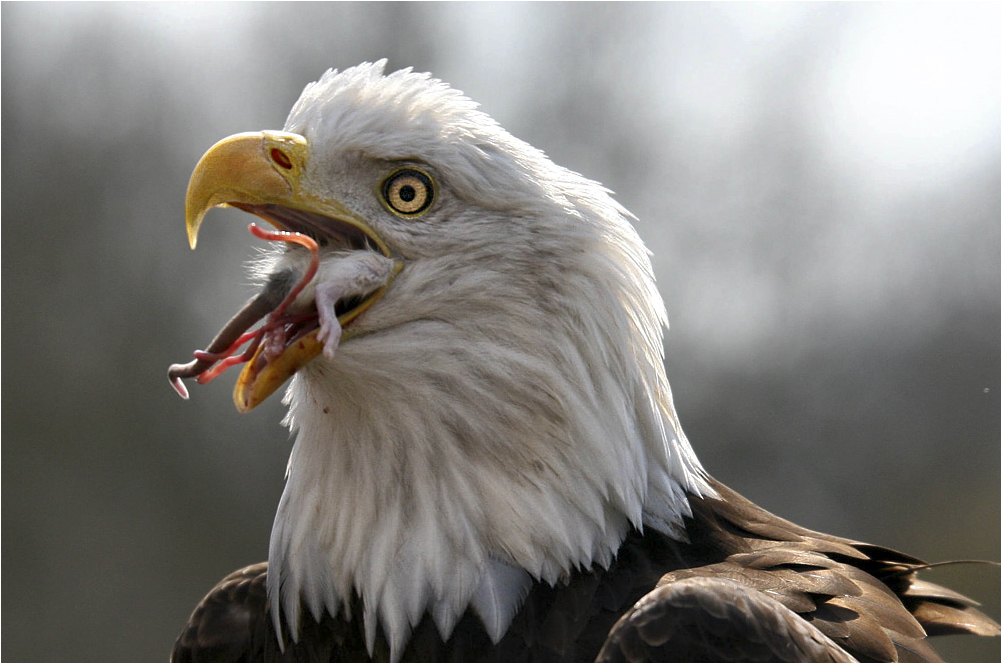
[682,480,999,661]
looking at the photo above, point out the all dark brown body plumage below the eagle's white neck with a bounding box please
[172,481,1000,662]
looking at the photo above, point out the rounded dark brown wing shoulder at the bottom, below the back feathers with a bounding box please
[597,577,854,663]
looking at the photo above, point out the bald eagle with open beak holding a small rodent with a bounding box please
[169,61,1000,661]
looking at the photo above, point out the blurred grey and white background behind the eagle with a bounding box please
[2,3,1000,661]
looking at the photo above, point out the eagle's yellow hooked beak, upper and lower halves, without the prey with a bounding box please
[185,131,391,413]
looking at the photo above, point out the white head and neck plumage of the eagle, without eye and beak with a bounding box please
[269,61,712,657]
